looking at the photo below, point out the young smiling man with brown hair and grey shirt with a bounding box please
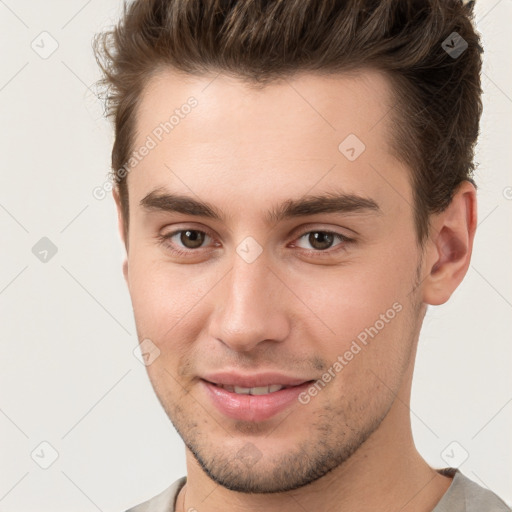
[95,0,509,512]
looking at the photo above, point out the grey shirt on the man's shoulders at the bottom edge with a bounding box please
[126,468,512,512]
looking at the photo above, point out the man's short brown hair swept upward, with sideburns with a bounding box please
[93,0,482,248]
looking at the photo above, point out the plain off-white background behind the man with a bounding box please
[0,0,512,512]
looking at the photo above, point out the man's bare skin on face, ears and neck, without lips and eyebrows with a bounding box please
[114,70,476,512]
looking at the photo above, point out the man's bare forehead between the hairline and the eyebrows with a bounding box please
[128,65,411,216]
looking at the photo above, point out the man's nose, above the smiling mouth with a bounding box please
[210,250,290,352]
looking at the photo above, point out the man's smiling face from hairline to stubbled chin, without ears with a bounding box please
[119,71,422,493]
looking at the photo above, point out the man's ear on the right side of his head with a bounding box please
[422,180,477,306]
